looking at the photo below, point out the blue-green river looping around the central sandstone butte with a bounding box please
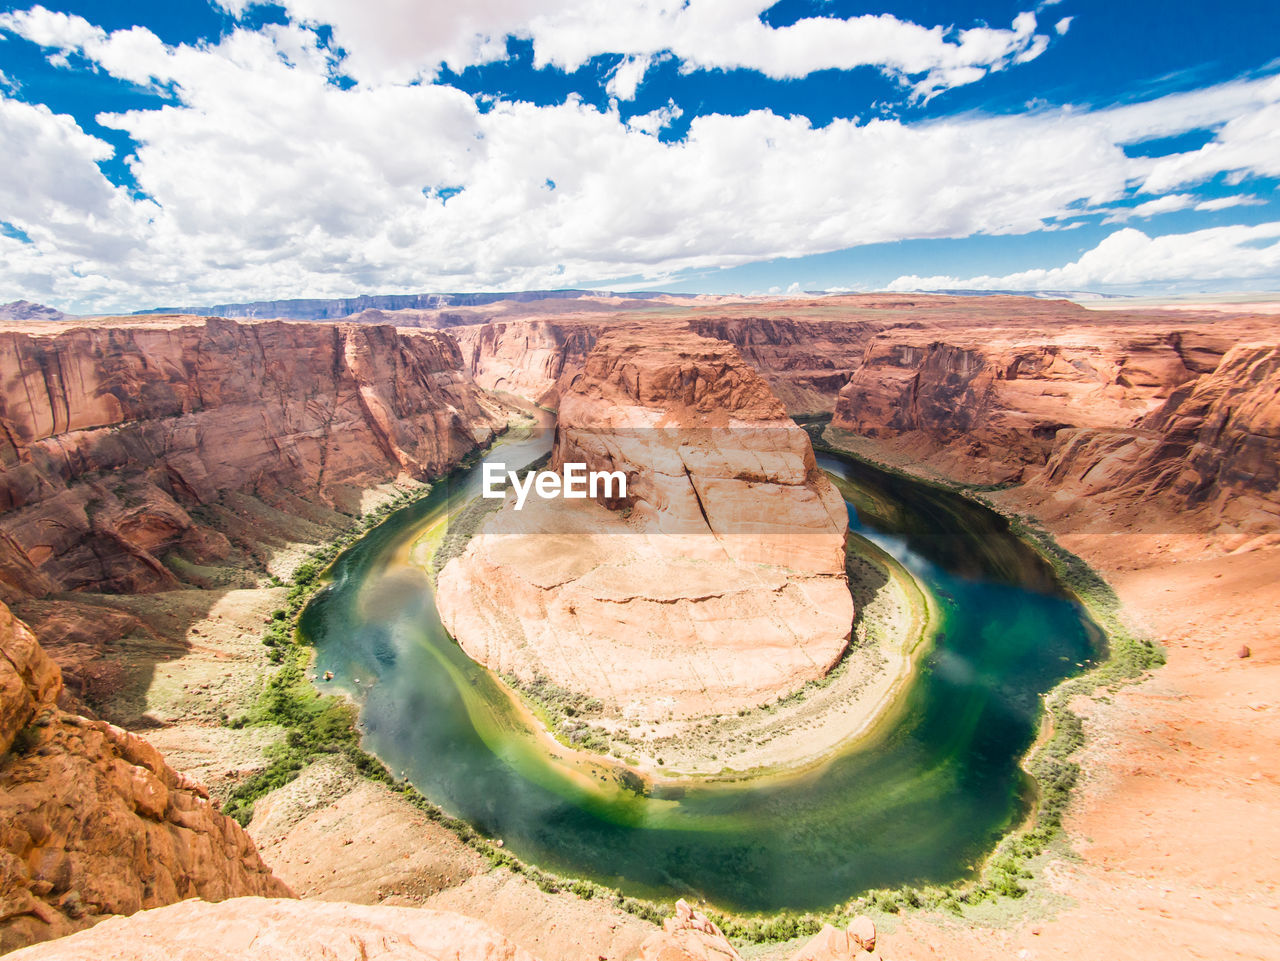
[301,436,1100,912]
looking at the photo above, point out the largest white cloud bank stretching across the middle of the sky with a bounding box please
[0,6,1280,310]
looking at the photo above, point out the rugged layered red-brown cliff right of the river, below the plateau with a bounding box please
[832,308,1280,540]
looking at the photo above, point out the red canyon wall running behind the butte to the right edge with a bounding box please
[452,294,1280,544]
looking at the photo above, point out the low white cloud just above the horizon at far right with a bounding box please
[888,223,1280,290]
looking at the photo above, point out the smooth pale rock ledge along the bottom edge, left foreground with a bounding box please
[12,897,534,961]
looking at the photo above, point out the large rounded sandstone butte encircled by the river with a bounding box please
[438,325,854,720]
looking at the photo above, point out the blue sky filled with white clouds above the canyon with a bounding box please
[0,0,1280,314]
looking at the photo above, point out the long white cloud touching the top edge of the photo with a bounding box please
[219,0,1048,100]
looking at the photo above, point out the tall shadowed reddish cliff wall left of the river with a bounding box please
[0,319,497,603]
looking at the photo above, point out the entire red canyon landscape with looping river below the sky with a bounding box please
[0,296,1280,957]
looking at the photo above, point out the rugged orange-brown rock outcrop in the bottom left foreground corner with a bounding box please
[0,604,292,952]
